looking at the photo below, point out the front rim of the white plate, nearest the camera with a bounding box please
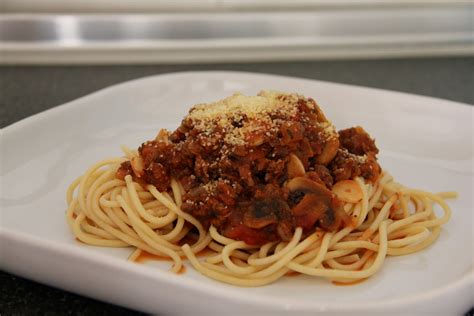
[0,227,474,312]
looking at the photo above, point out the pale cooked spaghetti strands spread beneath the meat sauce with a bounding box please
[67,91,456,286]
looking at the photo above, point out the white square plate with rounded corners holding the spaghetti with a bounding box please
[0,72,474,315]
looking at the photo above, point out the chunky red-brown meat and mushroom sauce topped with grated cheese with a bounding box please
[117,91,381,245]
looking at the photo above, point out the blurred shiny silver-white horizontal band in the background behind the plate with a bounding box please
[0,5,474,64]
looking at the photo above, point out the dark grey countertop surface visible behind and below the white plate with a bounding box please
[0,57,474,315]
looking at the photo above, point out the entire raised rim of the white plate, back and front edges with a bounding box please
[0,71,474,312]
